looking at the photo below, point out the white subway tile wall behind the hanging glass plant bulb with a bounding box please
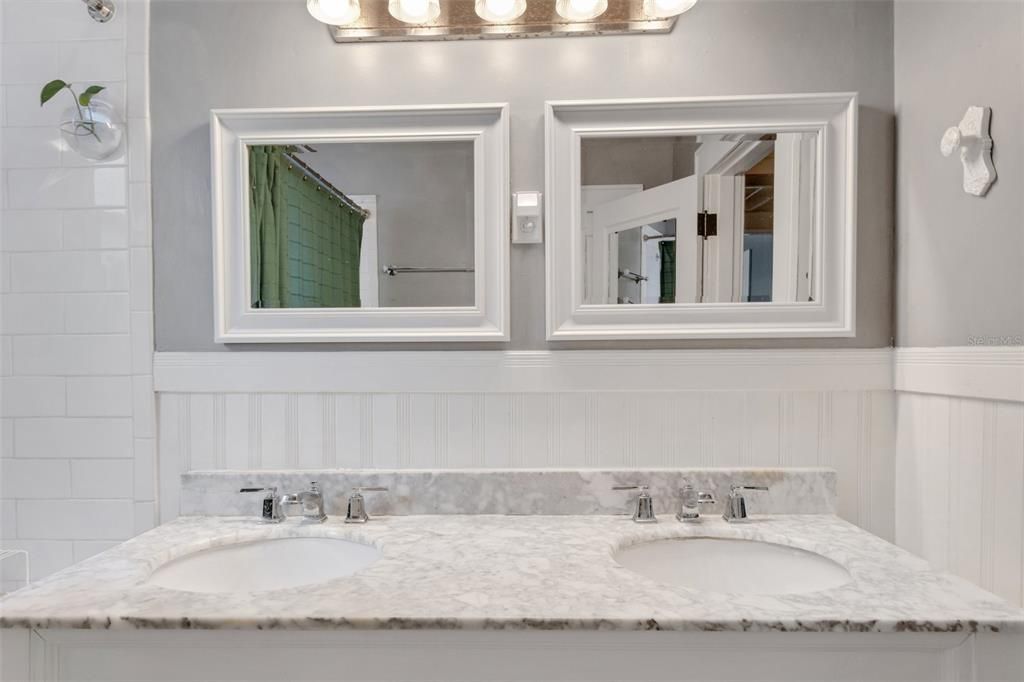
[0,0,157,592]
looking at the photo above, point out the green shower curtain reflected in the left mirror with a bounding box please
[249,145,366,308]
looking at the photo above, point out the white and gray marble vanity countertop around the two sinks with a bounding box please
[0,514,1024,632]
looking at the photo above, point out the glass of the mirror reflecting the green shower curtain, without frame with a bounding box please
[248,140,474,308]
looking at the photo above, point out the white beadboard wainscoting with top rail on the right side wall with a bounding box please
[896,347,1024,605]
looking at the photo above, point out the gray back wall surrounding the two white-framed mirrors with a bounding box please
[150,0,894,351]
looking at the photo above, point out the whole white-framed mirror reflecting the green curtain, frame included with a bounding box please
[210,103,509,343]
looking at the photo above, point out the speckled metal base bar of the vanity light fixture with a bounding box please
[329,0,678,43]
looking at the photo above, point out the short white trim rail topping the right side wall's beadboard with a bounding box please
[894,346,1024,402]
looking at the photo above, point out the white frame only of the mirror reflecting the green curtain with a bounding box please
[210,103,509,343]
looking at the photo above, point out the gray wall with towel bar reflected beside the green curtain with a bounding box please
[304,141,473,307]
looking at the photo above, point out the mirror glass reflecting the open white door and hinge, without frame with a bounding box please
[580,131,817,305]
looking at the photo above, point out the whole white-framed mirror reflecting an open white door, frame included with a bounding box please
[545,93,857,340]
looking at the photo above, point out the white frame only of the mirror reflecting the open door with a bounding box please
[545,92,857,341]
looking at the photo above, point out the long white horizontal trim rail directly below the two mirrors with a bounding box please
[154,348,893,393]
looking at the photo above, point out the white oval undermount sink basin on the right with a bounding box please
[614,538,851,594]
